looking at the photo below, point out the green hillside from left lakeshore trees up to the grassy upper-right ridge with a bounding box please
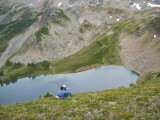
[0,18,152,83]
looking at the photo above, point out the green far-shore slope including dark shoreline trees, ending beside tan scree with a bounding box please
[0,31,121,83]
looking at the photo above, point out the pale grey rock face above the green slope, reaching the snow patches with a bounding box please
[0,0,159,66]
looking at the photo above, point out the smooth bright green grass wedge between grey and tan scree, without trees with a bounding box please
[55,33,121,73]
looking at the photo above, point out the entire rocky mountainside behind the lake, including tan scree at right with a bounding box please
[0,0,160,80]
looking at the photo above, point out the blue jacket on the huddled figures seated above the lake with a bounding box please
[57,89,71,99]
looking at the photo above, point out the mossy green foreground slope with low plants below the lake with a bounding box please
[0,73,160,120]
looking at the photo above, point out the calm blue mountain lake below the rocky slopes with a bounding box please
[0,66,139,104]
